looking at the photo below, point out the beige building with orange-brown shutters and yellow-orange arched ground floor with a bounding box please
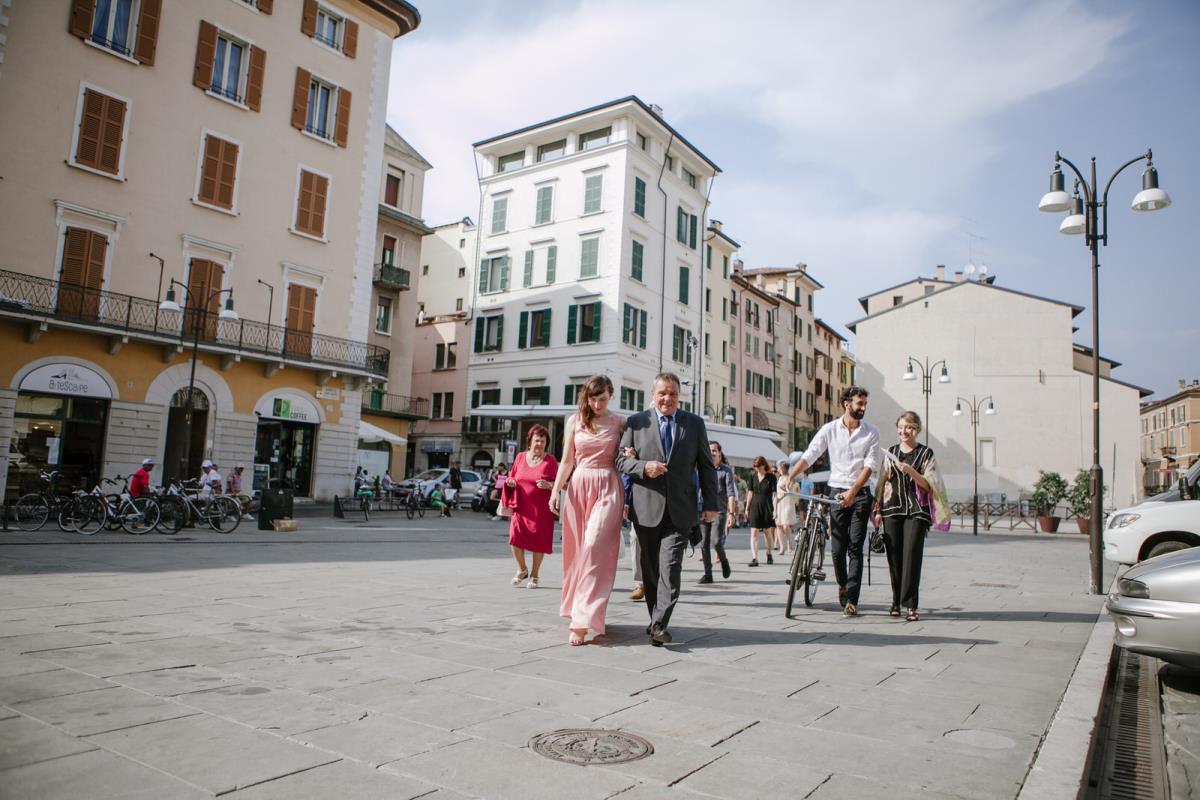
[0,0,420,498]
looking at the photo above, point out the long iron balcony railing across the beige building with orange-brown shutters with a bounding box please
[0,270,390,378]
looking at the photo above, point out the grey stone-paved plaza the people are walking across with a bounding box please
[0,513,1102,800]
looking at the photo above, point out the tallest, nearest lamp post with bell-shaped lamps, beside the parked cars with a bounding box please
[1038,150,1171,595]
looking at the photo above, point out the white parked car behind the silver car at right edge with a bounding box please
[1104,462,1200,564]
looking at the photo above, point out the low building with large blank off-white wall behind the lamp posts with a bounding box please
[848,268,1148,506]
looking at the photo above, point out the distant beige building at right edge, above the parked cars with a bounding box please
[1140,379,1200,495]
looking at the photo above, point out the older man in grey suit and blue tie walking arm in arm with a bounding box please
[617,372,719,648]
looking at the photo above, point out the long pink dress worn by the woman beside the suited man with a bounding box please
[559,415,624,633]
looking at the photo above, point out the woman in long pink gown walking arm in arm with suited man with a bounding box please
[550,375,624,645]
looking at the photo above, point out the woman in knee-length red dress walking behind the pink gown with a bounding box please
[500,425,558,589]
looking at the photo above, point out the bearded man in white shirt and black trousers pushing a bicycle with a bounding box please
[791,386,880,616]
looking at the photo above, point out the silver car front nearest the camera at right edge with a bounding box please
[1106,547,1200,669]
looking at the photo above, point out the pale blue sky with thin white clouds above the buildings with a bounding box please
[388,0,1200,397]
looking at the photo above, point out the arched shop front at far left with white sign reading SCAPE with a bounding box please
[6,363,113,499]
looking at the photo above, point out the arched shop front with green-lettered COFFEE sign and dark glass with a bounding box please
[254,392,320,498]
